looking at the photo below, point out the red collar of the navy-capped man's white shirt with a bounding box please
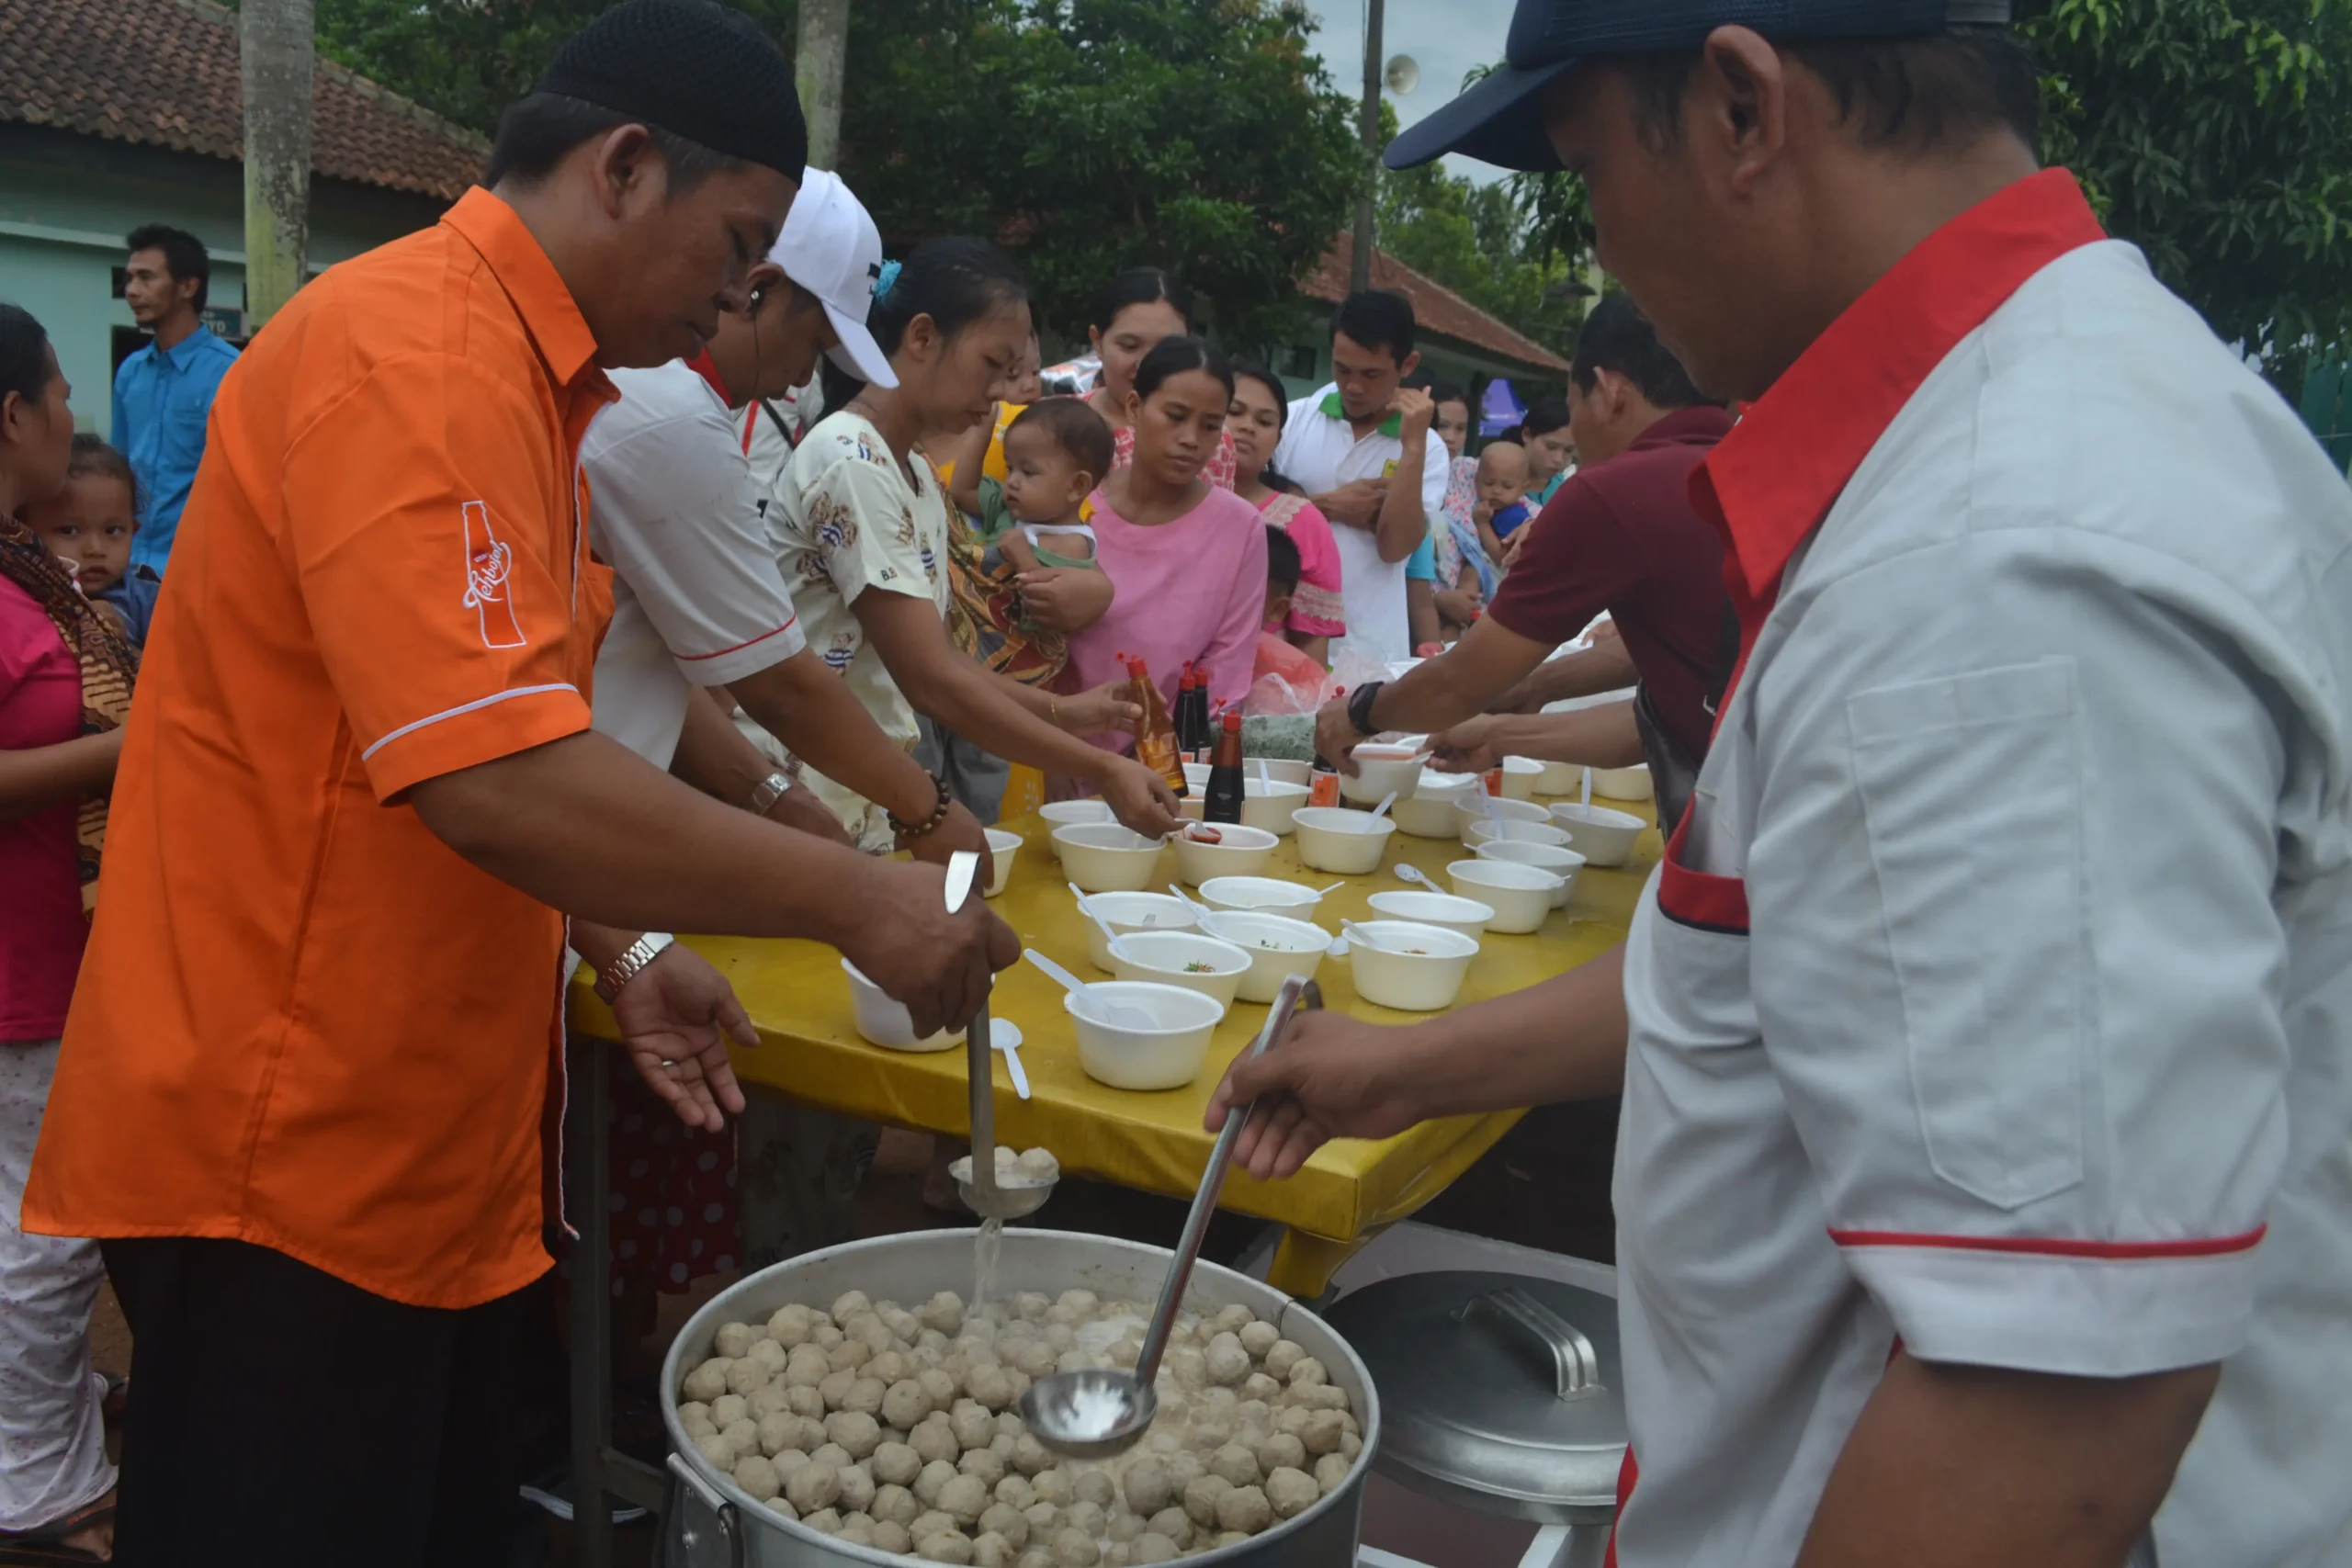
[1691,169,2108,602]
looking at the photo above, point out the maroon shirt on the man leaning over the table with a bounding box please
[1487,407,1731,757]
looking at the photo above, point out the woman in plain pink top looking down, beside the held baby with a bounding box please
[1070,339,1265,745]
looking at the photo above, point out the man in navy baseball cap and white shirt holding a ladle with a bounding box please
[1211,0,2352,1568]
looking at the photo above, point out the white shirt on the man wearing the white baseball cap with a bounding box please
[581,360,802,769]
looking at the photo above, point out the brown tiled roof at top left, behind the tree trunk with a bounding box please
[0,0,489,202]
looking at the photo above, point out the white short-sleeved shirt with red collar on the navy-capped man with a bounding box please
[1616,172,2352,1568]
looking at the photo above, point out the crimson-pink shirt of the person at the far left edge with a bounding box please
[0,579,89,1042]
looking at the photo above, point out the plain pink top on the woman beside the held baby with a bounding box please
[1070,487,1265,750]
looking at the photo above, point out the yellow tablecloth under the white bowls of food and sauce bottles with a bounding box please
[571,807,1658,1295]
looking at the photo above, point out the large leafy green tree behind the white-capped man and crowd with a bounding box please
[318,0,1366,344]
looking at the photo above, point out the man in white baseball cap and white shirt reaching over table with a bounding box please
[581,169,988,861]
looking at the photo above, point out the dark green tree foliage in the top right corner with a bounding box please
[2023,0,2352,383]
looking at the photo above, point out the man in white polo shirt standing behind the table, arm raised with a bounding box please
[1275,289,1452,665]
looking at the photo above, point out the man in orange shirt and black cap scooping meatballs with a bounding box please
[24,0,1018,1568]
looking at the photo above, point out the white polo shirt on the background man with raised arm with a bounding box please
[1275,383,1453,665]
